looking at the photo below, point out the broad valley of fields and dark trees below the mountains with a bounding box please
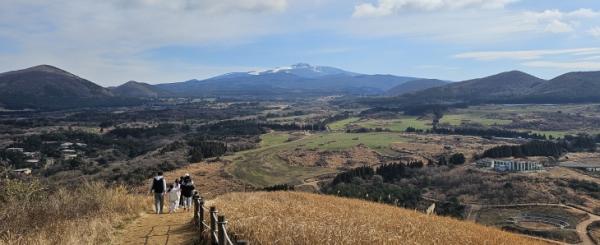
[0,64,600,244]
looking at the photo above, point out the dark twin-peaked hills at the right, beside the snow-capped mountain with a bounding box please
[398,71,600,106]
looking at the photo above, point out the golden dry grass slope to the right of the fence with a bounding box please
[209,192,545,245]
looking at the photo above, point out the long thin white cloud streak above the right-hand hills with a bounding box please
[453,48,600,61]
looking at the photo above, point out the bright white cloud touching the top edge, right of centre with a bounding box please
[353,0,518,17]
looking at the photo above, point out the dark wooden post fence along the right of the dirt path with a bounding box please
[194,195,248,245]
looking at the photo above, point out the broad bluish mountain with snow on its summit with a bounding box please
[156,63,417,96]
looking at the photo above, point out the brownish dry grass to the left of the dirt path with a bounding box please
[0,181,147,244]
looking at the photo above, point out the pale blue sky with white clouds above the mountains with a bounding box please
[0,0,600,86]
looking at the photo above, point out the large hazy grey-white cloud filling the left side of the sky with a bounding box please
[0,0,288,84]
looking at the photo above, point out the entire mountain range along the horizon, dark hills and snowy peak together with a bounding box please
[0,64,600,109]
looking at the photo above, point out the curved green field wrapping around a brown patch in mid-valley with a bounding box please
[227,132,406,186]
